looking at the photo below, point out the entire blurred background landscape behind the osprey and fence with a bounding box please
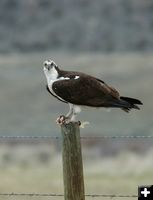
[0,0,153,199]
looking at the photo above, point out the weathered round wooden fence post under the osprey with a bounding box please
[61,122,85,200]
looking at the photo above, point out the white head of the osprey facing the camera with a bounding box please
[43,59,58,83]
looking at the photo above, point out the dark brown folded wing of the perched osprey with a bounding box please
[52,74,119,107]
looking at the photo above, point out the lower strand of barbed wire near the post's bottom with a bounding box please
[0,192,138,198]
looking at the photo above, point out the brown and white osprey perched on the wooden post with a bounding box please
[43,59,142,124]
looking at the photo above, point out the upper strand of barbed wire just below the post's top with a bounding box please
[0,135,153,140]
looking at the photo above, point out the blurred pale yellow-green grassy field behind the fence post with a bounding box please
[0,145,153,199]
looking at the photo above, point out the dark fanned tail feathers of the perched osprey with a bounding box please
[119,97,143,112]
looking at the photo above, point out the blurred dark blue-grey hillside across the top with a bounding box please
[0,0,153,53]
